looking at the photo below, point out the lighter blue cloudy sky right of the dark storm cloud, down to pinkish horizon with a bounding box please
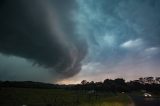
[59,0,160,82]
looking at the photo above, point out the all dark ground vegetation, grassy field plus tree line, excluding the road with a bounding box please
[0,78,160,106]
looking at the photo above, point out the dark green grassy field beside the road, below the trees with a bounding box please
[0,88,132,106]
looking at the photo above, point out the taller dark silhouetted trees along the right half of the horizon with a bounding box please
[73,78,160,92]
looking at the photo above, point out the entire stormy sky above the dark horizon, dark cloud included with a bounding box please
[0,0,160,84]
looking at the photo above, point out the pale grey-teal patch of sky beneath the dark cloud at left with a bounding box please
[0,54,55,83]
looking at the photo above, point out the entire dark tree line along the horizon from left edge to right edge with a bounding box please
[0,78,160,92]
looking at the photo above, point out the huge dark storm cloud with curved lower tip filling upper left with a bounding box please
[0,0,87,77]
